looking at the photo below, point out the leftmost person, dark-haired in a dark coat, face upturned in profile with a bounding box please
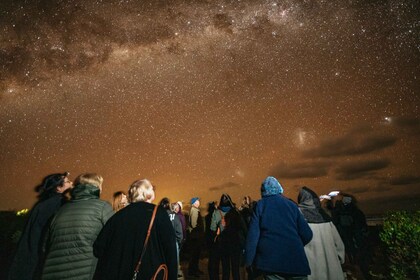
[9,172,72,280]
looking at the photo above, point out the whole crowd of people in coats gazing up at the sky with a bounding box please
[9,172,369,280]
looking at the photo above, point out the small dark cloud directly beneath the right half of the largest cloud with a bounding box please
[335,159,391,180]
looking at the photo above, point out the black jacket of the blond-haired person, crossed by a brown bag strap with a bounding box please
[93,202,178,280]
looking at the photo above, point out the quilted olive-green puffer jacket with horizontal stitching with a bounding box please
[42,185,114,280]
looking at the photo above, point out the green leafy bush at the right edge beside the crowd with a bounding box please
[380,211,420,279]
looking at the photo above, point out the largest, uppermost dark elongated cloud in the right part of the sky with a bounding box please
[303,130,397,158]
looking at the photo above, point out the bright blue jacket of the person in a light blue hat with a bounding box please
[246,195,312,276]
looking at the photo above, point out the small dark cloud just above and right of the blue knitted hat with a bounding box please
[270,162,331,178]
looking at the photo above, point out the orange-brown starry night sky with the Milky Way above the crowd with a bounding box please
[0,0,420,214]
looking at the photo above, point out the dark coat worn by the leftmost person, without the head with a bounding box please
[9,193,64,280]
